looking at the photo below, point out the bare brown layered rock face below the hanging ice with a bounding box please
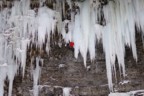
[4,34,144,96]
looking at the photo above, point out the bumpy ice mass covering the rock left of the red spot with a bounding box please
[0,0,56,96]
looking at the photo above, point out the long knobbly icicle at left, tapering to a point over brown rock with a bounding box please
[9,0,33,77]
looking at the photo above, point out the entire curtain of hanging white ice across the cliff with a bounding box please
[0,0,144,96]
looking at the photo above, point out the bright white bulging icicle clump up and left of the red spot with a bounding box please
[37,7,56,49]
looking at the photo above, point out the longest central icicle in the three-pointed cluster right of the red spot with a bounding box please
[80,0,91,67]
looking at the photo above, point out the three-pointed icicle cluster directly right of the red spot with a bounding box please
[62,1,96,67]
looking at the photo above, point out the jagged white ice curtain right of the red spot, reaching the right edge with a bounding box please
[62,0,144,91]
